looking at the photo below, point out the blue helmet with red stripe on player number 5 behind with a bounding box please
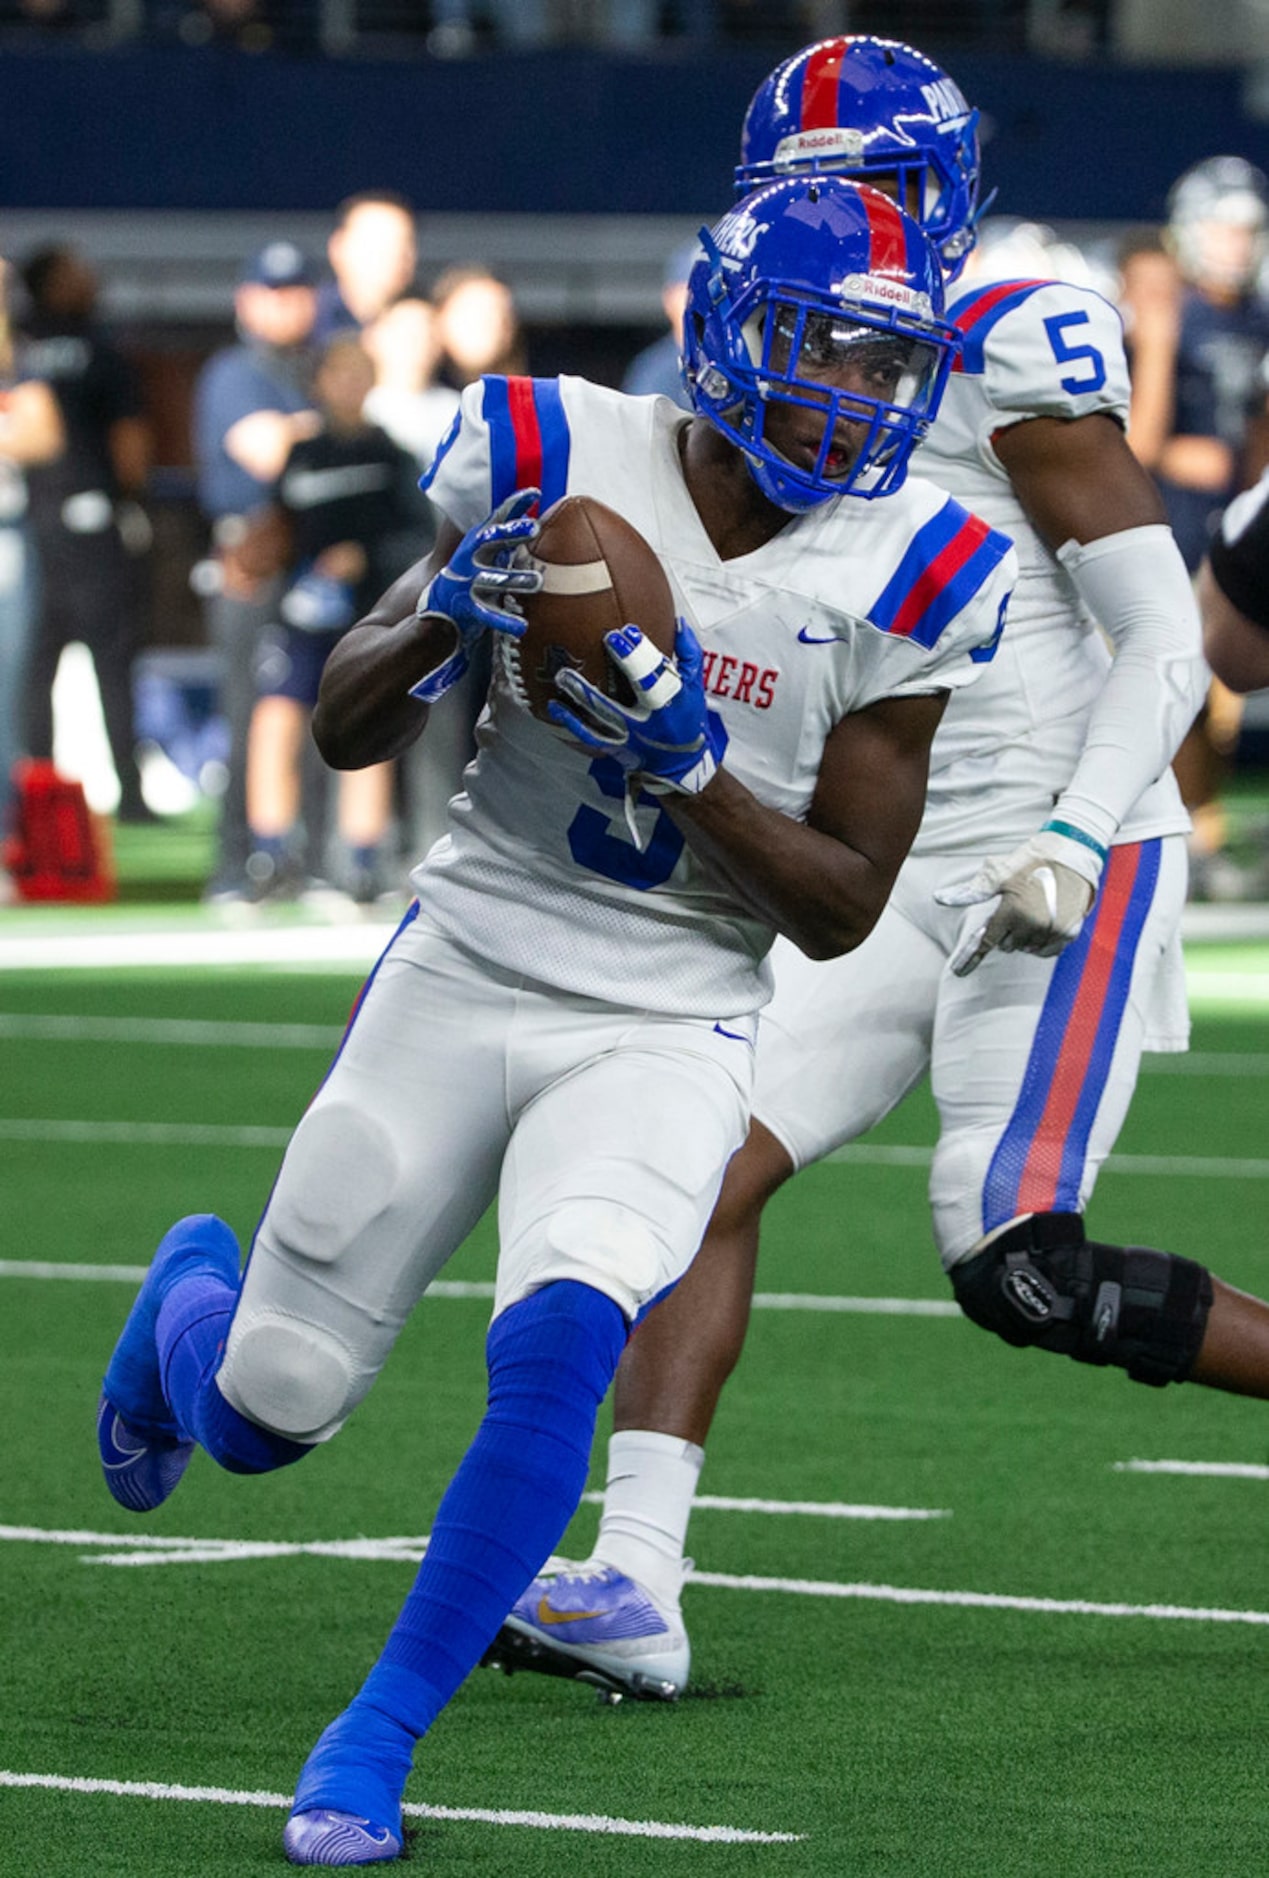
[736,34,986,280]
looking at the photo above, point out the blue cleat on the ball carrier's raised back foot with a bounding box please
[98,1213,238,1514]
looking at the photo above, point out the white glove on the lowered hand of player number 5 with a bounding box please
[935,823,1106,978]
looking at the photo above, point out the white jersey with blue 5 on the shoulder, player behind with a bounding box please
[912,280,1188,854]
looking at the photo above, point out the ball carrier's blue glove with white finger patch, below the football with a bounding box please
[546,620,726,796]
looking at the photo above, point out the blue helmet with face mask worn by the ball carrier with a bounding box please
[683,177,959,515]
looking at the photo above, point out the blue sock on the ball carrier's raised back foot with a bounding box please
[156,1271,312,1474]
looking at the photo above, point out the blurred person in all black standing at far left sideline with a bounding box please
[23,242,150,821]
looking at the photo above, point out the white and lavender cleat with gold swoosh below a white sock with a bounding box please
[481,1564,691,1701]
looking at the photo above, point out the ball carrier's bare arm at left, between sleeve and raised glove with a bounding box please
[313,522,462,770]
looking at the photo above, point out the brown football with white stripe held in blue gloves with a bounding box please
[501,496,676,719]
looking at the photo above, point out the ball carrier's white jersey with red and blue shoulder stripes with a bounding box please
[413,377,1016,1018]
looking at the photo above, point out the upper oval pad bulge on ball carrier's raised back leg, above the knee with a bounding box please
[261,1102,400,1266]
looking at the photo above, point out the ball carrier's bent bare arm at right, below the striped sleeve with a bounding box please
[663,691,946,958]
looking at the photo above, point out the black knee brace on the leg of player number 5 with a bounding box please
[948,1213,1213,1388]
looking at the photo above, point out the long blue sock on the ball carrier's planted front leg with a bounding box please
[295,1281,627,1825]
